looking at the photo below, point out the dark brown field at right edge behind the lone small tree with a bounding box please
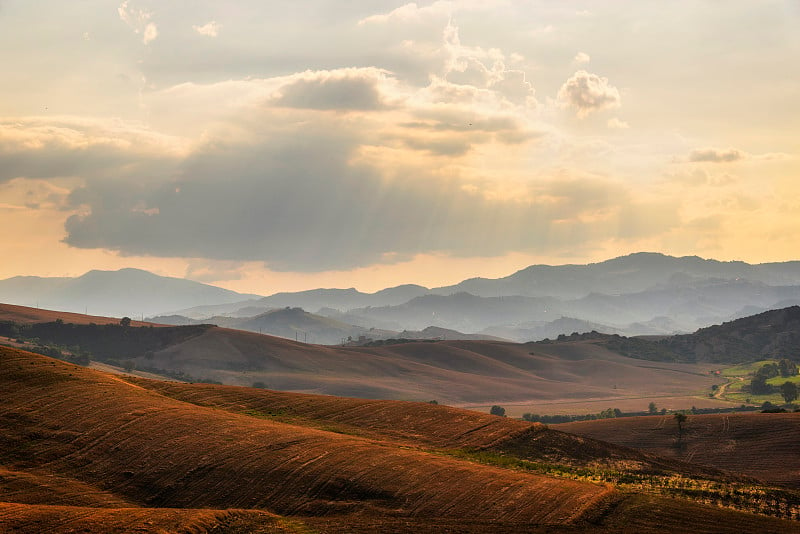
[553,413,800,488]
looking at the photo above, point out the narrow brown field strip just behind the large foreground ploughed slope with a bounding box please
[126,378,744,480]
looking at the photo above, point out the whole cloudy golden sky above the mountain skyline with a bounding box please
[0,0,800,294]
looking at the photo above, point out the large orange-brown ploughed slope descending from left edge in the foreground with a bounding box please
[0,348,615,524]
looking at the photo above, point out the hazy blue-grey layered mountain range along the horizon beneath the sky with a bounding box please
[0,253,800,343]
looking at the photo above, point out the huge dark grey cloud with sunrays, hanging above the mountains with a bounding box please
[57,108,674,271]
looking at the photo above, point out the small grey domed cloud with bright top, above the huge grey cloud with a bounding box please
[274,68,387,111]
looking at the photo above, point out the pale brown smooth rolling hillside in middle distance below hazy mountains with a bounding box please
[128,328,716,404]
